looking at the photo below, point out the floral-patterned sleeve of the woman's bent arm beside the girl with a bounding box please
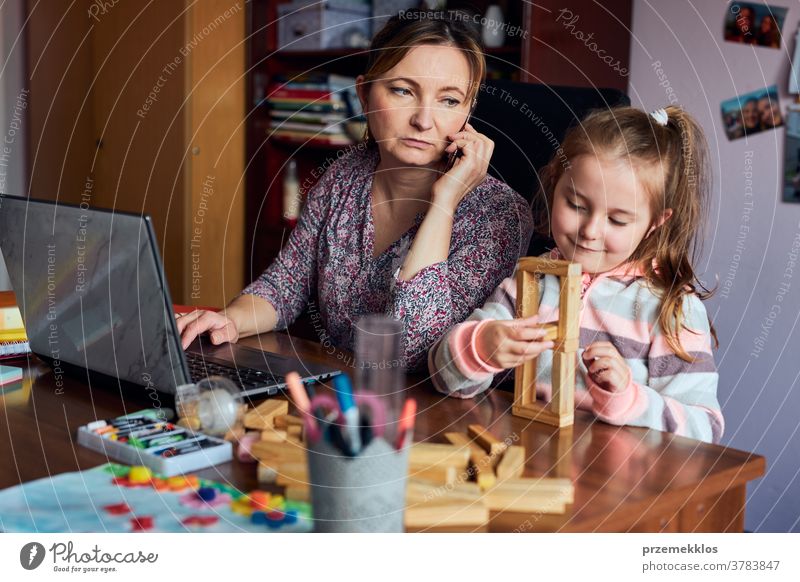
[386,185,532,370]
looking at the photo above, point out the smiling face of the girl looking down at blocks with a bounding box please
[551,155,672,274]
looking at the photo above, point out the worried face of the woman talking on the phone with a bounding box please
[358,45,471,167]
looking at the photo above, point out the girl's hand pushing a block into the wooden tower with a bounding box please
[475,315,553,369]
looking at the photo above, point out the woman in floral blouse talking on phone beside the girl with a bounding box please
[178,12,532,369]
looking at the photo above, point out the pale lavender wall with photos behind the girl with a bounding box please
[629,0,800,532]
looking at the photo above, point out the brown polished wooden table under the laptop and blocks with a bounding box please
[0,333,765,532]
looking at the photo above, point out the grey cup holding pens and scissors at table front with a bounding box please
[308,438,410,533]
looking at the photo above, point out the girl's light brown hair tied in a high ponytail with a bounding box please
[537,106,716,361]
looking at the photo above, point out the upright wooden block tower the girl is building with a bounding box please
[512,257,581,427]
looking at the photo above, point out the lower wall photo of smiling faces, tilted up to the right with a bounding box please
[720,85,783,140]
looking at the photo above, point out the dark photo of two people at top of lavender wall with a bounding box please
[724,0,788,49]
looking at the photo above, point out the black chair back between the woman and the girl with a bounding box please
[470,80,630,256]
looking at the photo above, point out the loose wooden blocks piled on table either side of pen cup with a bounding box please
[244,399,573,530]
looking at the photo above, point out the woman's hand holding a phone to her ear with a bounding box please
[431,123,494,213]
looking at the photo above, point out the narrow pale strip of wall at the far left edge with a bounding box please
[0,0,28,290]
